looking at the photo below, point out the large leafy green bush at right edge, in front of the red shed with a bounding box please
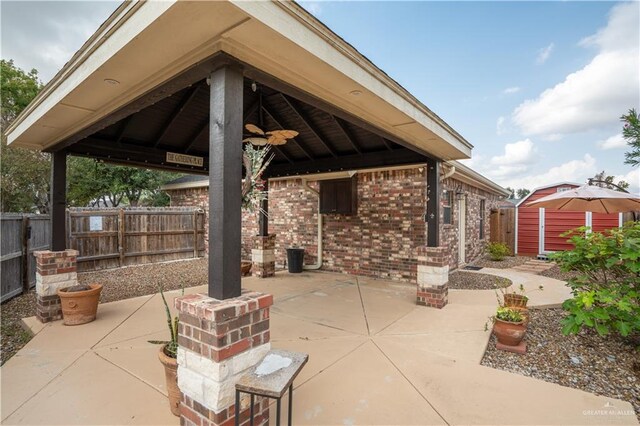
[552,222,640,336]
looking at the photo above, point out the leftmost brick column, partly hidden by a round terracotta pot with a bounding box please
[33,250,78,323]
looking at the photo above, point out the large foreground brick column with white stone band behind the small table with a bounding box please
[175,290,273,426]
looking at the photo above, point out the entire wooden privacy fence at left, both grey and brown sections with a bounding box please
[0,208,205,301]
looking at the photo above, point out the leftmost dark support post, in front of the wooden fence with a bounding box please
[50,151,67,251]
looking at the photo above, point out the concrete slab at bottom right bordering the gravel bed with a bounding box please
[378,339,637,425]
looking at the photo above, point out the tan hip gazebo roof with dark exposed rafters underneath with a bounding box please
[7,1,471,176]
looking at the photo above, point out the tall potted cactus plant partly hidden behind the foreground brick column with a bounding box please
[149,284,184,416]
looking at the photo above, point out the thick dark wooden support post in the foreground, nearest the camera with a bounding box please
[208,66,243,300]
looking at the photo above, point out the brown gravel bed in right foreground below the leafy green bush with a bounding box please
[482,308,640,418]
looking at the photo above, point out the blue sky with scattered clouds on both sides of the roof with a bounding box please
[0,1,640,192]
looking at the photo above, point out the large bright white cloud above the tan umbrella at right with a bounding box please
[512,2,640,137]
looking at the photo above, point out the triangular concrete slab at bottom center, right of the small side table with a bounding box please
[270,342,444,425]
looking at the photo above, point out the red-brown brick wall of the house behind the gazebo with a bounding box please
[169,167,499,282]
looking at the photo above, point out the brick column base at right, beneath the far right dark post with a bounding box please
[417,247,449,309]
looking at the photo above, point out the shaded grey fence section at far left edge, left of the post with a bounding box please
[0,213,49,302]
